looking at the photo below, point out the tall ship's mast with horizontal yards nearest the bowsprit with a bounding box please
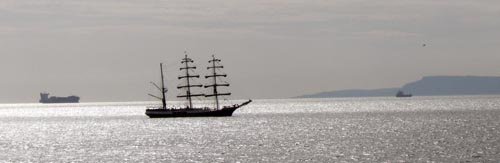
[205,55,231,110]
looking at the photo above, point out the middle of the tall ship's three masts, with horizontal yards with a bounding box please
[177,54,204,108]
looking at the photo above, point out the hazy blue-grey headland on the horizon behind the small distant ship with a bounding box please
[297,76,500,98]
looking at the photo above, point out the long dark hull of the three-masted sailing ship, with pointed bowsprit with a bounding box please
[146,100,252,118]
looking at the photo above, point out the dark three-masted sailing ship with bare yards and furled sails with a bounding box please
[146,55,252,118]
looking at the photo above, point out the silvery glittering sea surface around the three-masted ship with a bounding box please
[0,96,500,162]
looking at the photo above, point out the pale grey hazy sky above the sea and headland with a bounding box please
[0,0,500,103]
